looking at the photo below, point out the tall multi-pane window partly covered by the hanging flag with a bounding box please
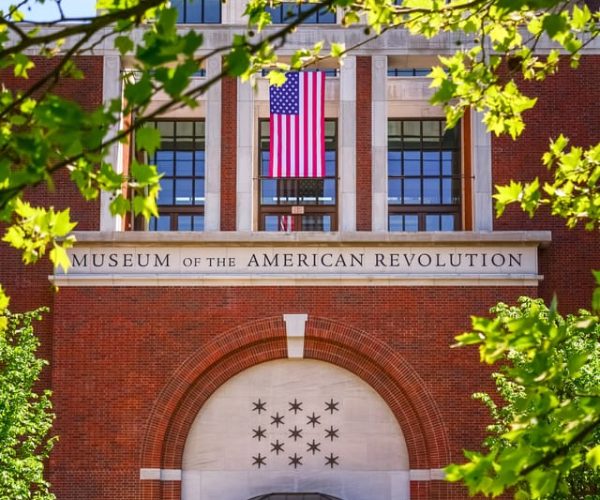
[259,120,337,231]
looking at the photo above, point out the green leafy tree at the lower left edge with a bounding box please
[0,298,56,500]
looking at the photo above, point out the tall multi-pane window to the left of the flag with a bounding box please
[149,121,205,231]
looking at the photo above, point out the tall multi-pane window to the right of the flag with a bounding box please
[388,120,461,231]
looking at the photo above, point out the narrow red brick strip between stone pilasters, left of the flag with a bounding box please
[221,78,237,231]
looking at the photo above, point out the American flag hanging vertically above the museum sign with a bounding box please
[269,71,325,177]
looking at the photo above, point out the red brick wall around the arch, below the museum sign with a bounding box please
[50,287,535,499]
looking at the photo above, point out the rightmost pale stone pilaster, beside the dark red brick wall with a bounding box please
[471,112,494,231]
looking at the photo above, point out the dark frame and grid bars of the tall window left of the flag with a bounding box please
[148,118,206,231]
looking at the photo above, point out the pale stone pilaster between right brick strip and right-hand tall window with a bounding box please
[371,55,388,231]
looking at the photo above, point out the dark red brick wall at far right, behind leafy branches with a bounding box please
[492,56,600,312]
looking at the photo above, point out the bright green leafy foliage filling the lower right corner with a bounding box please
[446,297,600,499]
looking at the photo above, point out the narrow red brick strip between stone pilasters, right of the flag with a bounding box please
[356,56,372,231]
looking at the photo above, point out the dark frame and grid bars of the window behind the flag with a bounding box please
[257,118,339,232]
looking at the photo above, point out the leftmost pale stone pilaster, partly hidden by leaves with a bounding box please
[100,55,123,231]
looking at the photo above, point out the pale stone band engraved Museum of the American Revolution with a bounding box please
[62,246,537,276]
